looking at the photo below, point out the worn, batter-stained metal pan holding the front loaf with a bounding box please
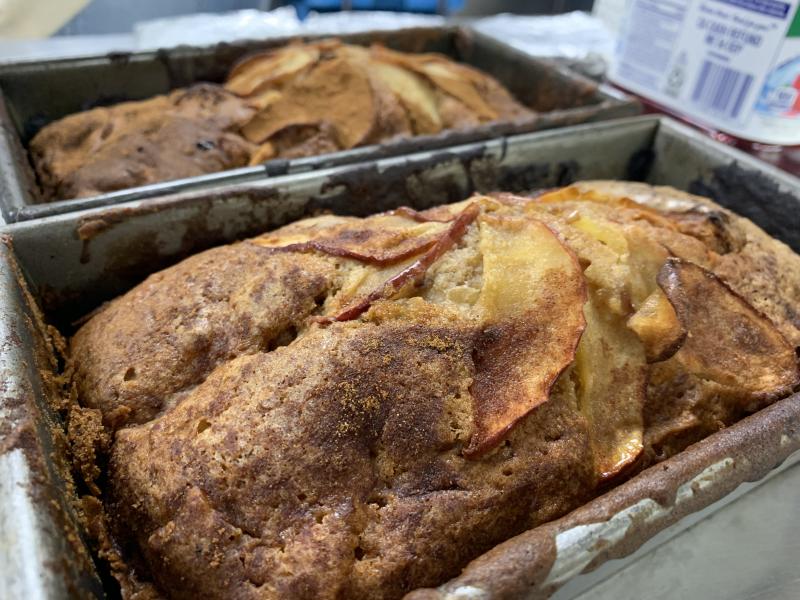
[0,117,800,599]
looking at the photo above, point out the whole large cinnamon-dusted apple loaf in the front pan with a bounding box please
[71,182,800,598]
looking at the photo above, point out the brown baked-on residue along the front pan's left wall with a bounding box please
[0,243,102,597]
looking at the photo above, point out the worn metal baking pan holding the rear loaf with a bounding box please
[0,27,640,221]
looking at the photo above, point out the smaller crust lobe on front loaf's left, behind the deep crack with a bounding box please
[71,244,334,427]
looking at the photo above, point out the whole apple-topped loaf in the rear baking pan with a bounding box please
[29,40,532,200]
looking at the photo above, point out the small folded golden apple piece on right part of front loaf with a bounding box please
[628,289,686,363]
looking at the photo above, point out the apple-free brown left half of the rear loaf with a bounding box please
[29,84,254,200]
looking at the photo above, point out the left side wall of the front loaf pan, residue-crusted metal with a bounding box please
[0,242,102,600]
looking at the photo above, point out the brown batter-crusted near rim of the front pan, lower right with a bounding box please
[406,394,800,600]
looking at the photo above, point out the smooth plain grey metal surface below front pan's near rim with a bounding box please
[576,457,800,600]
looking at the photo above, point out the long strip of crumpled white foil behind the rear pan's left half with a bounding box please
[134,6,444,50]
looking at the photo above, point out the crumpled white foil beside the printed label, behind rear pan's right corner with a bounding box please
[472,11,614,77]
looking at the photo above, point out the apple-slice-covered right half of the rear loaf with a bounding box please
[225,40,532,164]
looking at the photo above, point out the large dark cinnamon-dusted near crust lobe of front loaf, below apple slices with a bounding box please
[104,320,591,598]
